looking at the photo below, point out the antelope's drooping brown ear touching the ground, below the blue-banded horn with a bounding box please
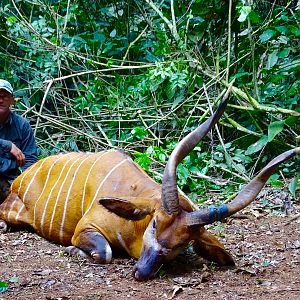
[193,228,235,266]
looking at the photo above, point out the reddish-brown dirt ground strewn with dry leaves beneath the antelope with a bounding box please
[0,193,300,300]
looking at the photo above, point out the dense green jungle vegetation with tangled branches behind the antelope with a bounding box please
[0,0,300,202]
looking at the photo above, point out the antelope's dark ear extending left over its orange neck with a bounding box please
[99,197,153,221]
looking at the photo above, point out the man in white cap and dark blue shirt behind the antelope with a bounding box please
[0,79,37,204]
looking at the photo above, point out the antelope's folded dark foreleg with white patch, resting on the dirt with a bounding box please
[65,229,112,264]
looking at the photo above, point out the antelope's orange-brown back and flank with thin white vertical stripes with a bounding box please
[2,151,159,245]
